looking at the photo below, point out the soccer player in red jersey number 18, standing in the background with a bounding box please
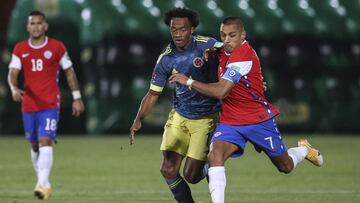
[8,11,84,200]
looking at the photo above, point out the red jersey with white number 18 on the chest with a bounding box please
[9,37,72,112]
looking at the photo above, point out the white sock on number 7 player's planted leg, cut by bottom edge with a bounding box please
[209,166,226,203]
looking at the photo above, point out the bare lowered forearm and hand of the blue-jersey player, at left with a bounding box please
[130,90,159,144]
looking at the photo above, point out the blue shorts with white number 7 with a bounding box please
[211,119,286,157]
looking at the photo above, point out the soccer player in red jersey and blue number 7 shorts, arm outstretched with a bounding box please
[169,17,323,203]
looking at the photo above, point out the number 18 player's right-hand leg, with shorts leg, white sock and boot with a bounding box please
[35,109,59,199]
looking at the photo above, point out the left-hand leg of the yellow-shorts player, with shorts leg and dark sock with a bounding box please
[160,110,194,203]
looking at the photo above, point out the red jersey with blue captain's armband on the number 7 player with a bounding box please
[218,41,279,125]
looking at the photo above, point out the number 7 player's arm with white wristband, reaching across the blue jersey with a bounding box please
[169,73,234,99]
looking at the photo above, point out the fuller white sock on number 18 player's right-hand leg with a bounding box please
[38,146,53,187]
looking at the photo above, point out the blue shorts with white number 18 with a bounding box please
[22,109,59,143]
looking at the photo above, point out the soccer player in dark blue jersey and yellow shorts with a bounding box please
[130,8,220,203]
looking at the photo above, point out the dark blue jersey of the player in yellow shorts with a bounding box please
[150,35,221,118]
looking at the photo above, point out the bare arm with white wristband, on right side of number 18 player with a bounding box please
[64,67,85,117]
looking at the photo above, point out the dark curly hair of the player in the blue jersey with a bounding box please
[164,7,199,27]
